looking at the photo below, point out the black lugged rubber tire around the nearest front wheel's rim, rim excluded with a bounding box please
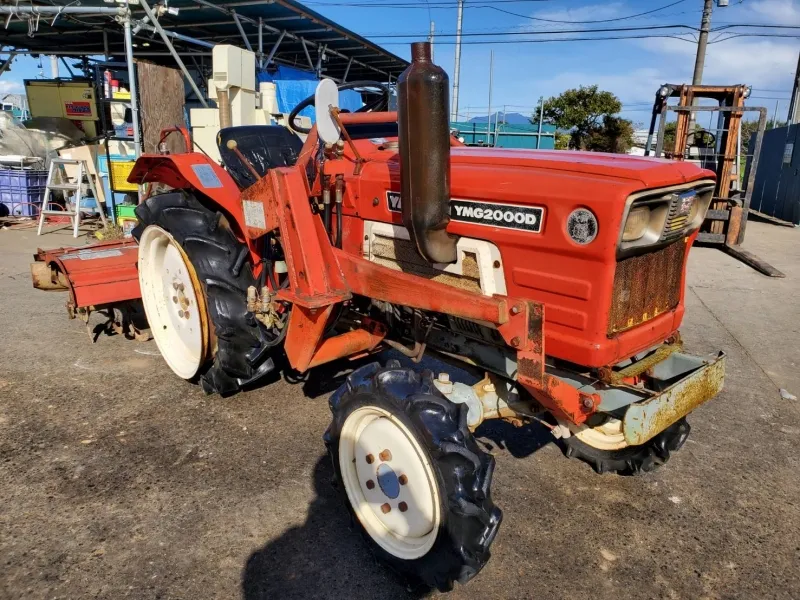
[324,361,502,592]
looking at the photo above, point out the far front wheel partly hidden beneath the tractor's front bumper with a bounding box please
[561,417,691,475]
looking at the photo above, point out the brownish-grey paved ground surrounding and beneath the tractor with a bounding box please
[0,222,800,600]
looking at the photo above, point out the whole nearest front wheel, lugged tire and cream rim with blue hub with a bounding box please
[325,361,502,591]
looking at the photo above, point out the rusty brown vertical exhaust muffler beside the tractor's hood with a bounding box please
[397,42,458,263]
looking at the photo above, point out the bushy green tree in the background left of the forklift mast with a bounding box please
[531,85,633,152]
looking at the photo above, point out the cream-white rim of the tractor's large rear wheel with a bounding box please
[139,225,208,379]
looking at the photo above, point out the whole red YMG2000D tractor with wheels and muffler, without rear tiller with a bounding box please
[125,43,724,590]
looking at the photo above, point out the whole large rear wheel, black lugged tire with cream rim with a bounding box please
[133,191,275,396]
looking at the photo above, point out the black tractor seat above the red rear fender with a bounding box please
[217,125,303,189]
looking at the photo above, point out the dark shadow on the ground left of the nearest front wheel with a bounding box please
[242,455,427,600]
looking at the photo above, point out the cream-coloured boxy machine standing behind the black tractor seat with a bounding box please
[189,44,311,163]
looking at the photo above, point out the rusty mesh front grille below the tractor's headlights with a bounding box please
[608,240,686,336]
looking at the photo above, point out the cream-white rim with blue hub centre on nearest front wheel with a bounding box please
[339,406,441,560]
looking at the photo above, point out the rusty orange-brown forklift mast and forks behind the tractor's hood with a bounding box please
[644,84,785,277]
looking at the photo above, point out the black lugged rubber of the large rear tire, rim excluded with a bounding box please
[133,191,275,396]
